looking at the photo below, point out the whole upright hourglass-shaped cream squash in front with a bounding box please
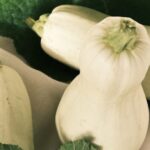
[56,17,150,150]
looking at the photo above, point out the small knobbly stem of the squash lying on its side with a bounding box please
[25,14,49,37]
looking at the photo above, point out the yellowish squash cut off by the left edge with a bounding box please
[0,65,34,150]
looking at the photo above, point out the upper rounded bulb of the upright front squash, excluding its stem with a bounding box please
[80,17,150,97]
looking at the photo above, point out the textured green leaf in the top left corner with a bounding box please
[0,0,36,26]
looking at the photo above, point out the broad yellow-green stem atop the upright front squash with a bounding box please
[103,19,137,53]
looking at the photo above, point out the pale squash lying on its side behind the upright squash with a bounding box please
[27,5,150,99]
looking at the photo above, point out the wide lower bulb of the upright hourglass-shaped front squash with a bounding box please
[56,75,149,150]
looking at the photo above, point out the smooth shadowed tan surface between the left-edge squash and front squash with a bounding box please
[0,36,66,150]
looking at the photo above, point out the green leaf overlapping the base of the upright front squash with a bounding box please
[59,140,101,150]
